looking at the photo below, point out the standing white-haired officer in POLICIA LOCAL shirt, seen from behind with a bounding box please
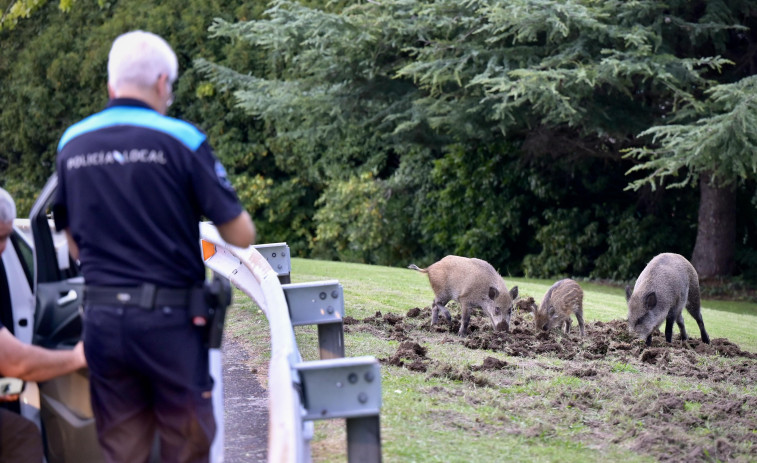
[53,31,255,463]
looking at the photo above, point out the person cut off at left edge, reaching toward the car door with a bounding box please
[0,188,87,463]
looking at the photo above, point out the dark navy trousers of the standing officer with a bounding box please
[84,305,216,463]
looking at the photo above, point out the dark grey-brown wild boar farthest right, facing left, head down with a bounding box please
[626,253,710,346]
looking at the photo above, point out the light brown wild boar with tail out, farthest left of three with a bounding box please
[408,256,518,336]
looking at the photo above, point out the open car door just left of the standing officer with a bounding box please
[29,175,104,463]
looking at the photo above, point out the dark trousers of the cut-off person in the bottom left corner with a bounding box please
[0,409,43,463]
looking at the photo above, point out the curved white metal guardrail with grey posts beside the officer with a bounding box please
[200,223,381,463]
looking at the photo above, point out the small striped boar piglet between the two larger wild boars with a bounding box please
[531,278,584,336]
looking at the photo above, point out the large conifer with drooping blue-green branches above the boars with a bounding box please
[204,0,756,276]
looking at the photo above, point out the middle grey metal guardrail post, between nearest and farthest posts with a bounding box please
[282,280,344,360]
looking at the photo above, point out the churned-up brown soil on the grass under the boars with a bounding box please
[358,307,757,386]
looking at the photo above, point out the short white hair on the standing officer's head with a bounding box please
[108,31,179,90]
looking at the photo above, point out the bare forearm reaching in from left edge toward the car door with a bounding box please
[0,327,87,381]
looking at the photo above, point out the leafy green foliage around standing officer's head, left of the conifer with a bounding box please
[0,0,263,213]
